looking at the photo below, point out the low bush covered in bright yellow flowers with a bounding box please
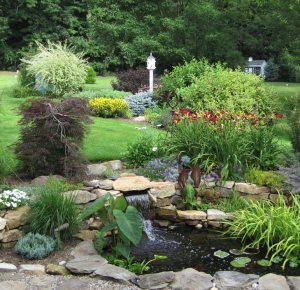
[89,97,129,118]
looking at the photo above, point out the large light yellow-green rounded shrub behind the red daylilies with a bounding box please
[177,63,278,116]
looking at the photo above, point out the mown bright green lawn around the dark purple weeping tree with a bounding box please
[0,72,160,162]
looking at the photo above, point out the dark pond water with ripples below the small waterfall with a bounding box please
[130,220,300,276]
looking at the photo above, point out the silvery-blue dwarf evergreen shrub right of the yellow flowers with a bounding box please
[124,91,156,116]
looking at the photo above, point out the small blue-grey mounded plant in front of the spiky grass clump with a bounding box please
[15,233,56,260]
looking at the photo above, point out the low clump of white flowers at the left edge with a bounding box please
[0,189,29,209]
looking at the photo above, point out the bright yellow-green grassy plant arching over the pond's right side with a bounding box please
[223,193,300,269]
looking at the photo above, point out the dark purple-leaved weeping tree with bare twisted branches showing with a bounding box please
[15,97,92,177]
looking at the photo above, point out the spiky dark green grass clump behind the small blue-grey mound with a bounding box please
[28,178,79,240]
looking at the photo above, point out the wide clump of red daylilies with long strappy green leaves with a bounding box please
[167,109,283,180]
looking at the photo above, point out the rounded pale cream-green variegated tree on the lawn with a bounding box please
[21,41,88,96]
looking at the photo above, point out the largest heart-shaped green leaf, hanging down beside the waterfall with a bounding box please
[114,206,143,245]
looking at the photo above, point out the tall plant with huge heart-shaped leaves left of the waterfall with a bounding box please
[79,192,143,258]
